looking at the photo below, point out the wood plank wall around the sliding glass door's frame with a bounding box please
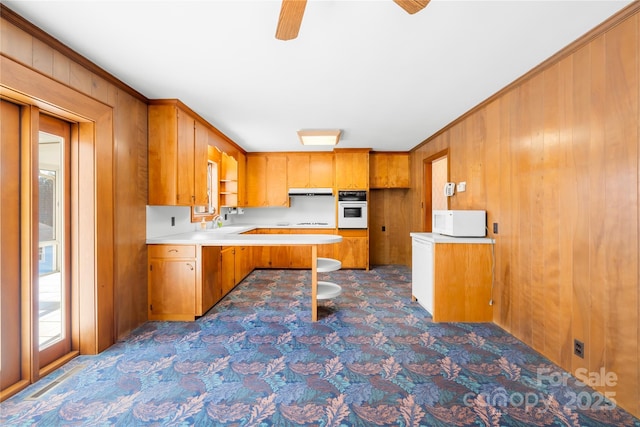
[0,14,147,338]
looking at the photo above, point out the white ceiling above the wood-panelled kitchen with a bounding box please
[2,0,631,151]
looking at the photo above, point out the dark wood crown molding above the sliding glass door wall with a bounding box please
[0,4,148,103]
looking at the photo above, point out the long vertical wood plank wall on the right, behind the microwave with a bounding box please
[411,7,640,416]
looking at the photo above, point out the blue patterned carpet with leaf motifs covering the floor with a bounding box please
[0,266,640,427]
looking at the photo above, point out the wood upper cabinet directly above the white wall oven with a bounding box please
[334,148,370,190]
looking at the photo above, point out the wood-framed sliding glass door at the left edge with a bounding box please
[0,100,72,400]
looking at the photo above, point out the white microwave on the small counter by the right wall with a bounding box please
[431,210,487,237]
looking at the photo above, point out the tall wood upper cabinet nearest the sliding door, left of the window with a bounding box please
[148,101,208,206]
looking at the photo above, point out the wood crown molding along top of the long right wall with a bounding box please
[411,1,640,152]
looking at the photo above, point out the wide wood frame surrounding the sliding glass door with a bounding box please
[0,56,115,400]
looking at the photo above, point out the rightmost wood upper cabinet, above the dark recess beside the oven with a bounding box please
[369,153,411,188]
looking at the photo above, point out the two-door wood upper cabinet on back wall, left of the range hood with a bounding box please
[246,153,289,207]
